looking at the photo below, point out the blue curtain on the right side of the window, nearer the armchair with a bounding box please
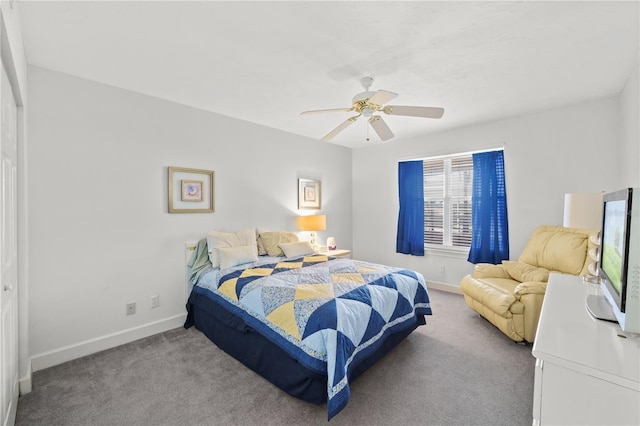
[468,151,509,264]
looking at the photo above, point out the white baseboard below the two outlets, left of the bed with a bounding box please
[30,313,187,372]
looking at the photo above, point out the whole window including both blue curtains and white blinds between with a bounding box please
[396,149,509,263]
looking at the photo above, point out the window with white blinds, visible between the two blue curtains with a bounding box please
[423,154,473,248]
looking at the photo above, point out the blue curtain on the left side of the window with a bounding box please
[396,161,424,256]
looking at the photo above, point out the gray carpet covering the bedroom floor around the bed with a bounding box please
[16,290,535,426]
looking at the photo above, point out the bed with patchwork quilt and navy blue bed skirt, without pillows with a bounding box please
[184,230,431,420]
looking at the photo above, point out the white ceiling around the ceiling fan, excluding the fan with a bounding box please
[19,0,639,147]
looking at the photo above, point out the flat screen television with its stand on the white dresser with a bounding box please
[587,188,640,333]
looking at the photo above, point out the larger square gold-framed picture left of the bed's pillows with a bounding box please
[168,167,214,213]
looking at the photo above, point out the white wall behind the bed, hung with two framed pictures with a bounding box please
[28,67,352,370]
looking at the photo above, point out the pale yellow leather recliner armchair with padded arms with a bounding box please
[460,226,597,342]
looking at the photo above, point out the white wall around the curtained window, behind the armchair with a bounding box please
[353,96,624,287]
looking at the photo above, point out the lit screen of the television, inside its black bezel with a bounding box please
[600,200,627,295]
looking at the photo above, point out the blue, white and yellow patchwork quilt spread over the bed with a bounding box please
[194,255,431,419]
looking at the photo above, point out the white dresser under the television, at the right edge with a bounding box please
[533,274,640,425]
